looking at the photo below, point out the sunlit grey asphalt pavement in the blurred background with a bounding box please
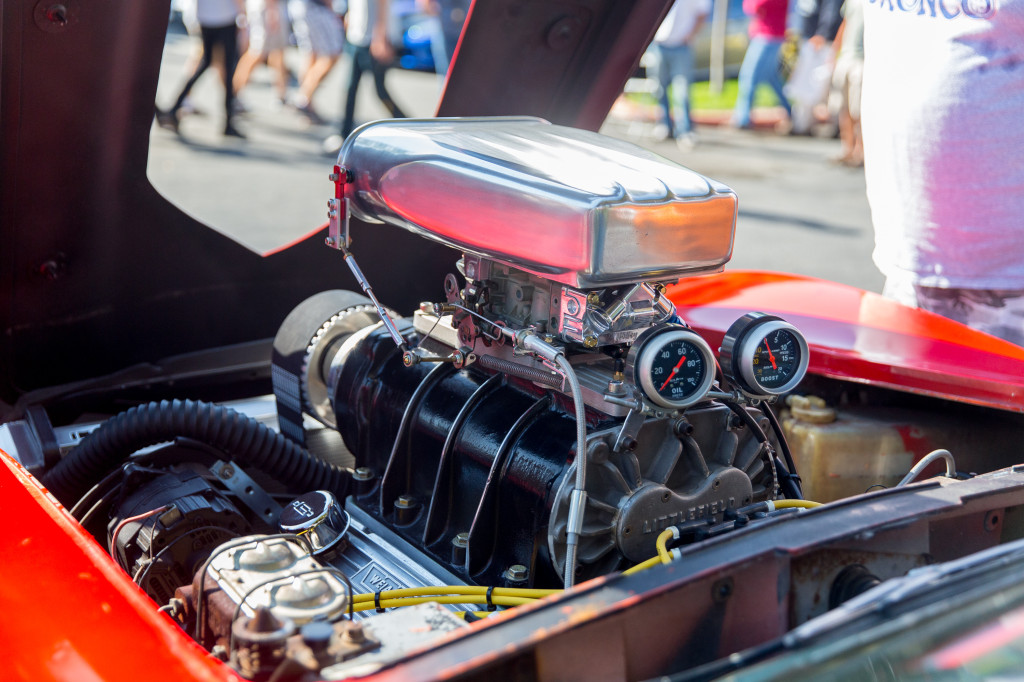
[148,25,883,291]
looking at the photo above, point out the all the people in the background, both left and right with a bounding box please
[157,0,1024,345]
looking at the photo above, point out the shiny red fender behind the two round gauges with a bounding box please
[669,270,1024,412]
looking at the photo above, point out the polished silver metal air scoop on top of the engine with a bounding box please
[338,118,736,288]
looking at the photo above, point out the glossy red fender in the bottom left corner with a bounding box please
[0,451,242,682]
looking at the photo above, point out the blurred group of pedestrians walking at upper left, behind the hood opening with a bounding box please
[156,0,470,152]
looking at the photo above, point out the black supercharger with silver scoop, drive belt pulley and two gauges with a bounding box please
[273,118,807,587]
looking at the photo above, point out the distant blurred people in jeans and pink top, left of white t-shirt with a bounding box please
[645,0,865,167]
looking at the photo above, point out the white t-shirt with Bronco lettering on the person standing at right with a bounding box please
[861,0,1024,289]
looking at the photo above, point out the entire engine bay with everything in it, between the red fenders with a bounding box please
[0,118,1024,680]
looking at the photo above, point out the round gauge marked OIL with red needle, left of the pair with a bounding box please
[631,325,715,410]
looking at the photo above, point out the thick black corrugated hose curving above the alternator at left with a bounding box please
[43,400,350,507]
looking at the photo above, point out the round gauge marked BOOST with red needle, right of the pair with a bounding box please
[720,312,809,396]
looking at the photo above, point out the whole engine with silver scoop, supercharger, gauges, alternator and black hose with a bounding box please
[34,118,808,679]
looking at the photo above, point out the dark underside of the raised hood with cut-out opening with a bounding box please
[0,0,670,403]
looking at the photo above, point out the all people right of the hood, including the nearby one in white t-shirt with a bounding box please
[653,0,1024,345]
